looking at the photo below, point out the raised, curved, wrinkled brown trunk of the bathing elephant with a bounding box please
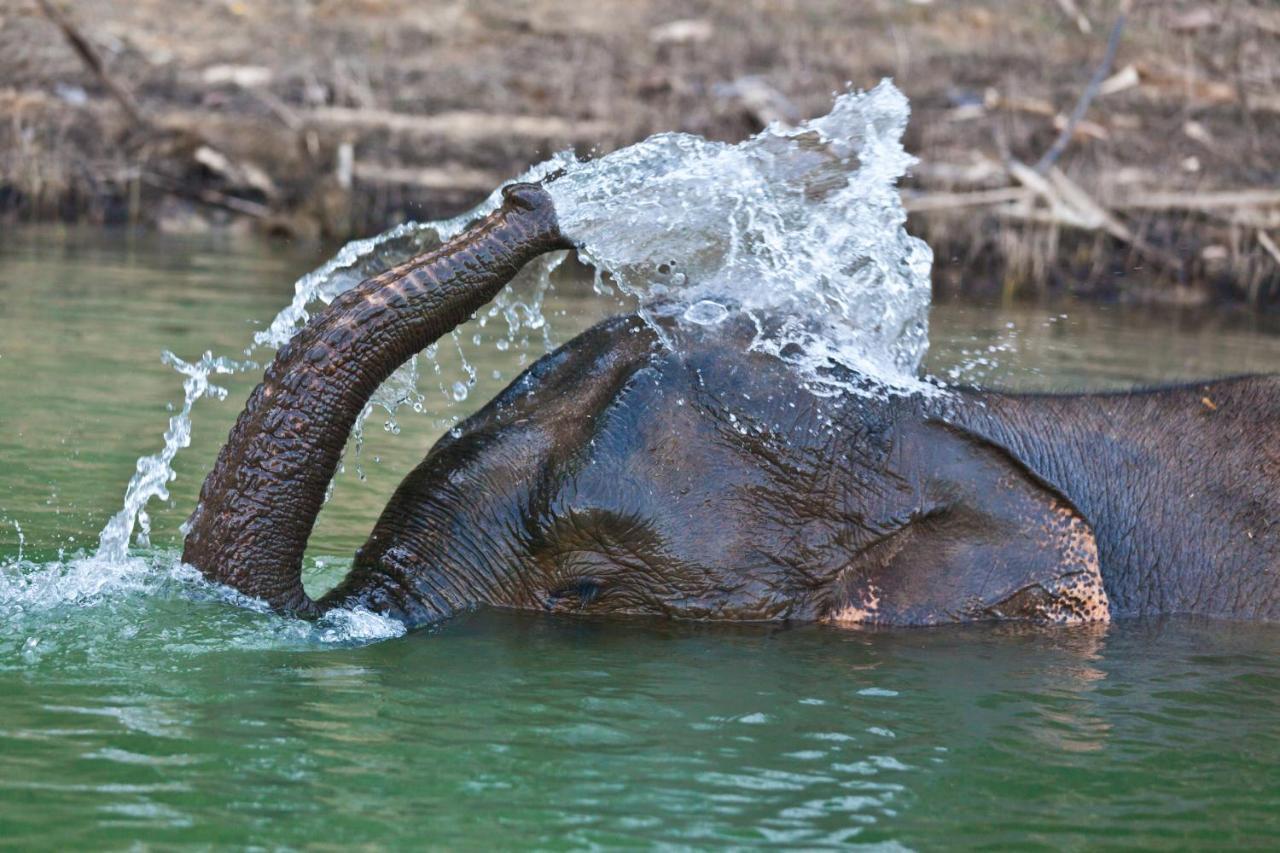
[183,184,572,615]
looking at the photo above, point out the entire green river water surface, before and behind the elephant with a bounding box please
[0,229,1280,849]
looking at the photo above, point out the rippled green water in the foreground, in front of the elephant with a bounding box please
[0,611,1280,847]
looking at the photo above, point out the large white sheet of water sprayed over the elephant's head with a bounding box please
[548,81,933,391]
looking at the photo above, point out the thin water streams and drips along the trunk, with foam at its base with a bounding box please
[0,154,583,637]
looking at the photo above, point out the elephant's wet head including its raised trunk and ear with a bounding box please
[183,178,1107,624]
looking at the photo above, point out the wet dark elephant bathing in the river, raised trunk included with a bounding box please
[183,184,1280,626]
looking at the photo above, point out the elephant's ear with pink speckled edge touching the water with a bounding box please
[826,424,1110,625]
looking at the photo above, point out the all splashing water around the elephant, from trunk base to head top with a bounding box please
[0,81,936,640]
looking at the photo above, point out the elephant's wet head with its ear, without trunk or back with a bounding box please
[314,308,1107,625]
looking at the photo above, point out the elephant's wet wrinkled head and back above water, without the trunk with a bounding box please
[324,312,1280,624]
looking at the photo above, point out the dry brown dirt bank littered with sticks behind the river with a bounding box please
[0,0,1280,305]
